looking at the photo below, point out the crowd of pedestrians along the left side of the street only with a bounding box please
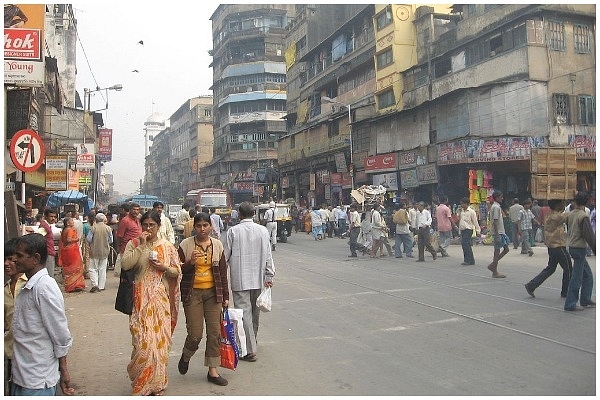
[4,202,275,396]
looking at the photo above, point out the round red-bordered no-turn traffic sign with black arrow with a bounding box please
[10,129,45,172]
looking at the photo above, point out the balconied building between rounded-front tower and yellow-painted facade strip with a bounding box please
[279,4,376,205]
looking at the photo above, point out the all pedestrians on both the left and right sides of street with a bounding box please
[4,190,596,395]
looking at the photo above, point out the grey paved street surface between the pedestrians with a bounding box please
[66,233,596,396]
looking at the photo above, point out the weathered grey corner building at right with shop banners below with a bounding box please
[384,4,596,204]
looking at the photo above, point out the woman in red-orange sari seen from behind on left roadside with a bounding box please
[58,217,85,293]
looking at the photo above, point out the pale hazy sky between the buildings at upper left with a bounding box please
[72,0,219,194]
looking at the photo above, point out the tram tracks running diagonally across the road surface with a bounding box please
[281,241,596,355]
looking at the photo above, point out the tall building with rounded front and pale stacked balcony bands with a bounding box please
[207,4,294,202]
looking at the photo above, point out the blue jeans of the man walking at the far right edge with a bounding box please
[565,247,594,310]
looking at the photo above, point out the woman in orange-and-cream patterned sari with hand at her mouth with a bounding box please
[121,211,181,396]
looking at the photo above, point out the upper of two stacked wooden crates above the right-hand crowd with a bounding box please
[531,147,577,175]
